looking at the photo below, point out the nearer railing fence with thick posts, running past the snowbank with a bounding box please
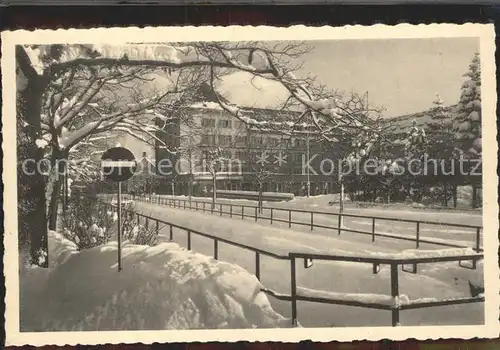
[103,202,484,326]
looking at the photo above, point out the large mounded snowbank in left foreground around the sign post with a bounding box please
[21,232,290,331]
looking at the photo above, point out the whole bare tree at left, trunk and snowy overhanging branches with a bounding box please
[16,42,378,264]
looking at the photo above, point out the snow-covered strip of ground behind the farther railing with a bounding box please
[131,196,483,249]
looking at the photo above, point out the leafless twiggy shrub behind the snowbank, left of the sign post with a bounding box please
[62,197,116,250]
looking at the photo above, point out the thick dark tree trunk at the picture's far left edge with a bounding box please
[16,46,48,267]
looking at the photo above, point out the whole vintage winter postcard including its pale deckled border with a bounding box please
[1,23,500,345]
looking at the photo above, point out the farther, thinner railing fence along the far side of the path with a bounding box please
[128,195,483,253]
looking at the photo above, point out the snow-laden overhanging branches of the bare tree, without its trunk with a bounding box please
[24,42,379,160]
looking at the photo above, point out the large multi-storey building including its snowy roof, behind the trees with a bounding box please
[155,85,346,195]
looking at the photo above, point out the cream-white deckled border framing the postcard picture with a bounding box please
[1,23,500,346]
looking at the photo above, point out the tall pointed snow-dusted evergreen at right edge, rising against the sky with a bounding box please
[454,53,481,158]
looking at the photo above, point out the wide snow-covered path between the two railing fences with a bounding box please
[135,202,484,327]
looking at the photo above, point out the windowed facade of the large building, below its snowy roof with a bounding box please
[155,108,342,195]
